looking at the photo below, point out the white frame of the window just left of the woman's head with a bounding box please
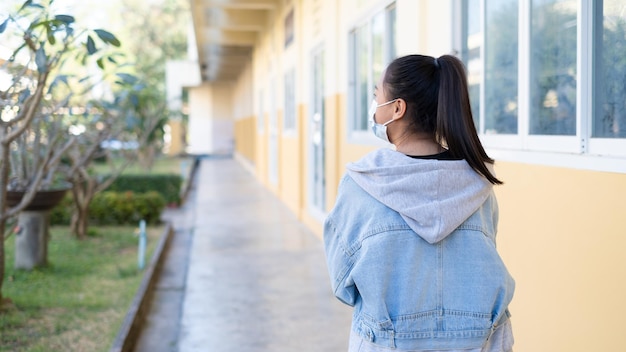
[346,0,398,147]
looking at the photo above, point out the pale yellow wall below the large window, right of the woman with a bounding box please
[496,162,626,352]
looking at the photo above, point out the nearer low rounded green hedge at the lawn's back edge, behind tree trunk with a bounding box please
[50,191,166,225]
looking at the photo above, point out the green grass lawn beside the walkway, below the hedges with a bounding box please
[0,227,164,352]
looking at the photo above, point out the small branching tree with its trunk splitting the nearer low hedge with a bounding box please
[68,79,163,239]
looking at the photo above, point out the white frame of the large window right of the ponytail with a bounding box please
[453,0,626,173]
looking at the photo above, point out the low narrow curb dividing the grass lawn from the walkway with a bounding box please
[109,224,174,352]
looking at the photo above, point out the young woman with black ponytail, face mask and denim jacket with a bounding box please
[324,55,515,352]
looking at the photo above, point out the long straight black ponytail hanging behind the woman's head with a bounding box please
[434,55,502,185]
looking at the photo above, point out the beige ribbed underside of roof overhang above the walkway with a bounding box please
[190,0,280,82]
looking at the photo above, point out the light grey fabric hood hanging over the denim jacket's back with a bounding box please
[347,149,493,243]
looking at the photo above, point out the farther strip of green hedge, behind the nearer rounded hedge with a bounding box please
[107,174,183,205]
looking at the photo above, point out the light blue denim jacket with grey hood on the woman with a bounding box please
[324,149,515,350]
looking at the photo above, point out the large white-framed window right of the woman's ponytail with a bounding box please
[455,0,626,161]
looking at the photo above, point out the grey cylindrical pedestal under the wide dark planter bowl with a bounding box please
[15,210,50,270]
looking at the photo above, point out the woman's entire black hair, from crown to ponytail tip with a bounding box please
[383,55,502,184]
